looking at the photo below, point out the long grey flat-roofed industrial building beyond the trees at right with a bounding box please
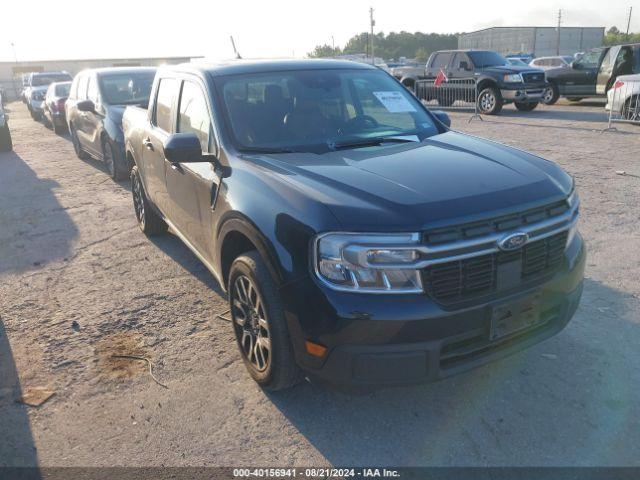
[458,27,604,57]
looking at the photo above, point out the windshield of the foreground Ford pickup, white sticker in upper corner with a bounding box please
[215,69,438,153]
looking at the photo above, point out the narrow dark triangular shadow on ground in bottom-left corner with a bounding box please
[0,318,38,470]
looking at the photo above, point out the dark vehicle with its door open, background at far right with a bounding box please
[543,43,640,105]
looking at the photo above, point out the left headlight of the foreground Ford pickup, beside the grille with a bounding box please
[313,233,423,293]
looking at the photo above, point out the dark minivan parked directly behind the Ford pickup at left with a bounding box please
[65,67,156,180]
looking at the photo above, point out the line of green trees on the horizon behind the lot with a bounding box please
[308,32,458,62]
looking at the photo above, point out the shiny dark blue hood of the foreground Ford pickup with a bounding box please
[249,131,573,231]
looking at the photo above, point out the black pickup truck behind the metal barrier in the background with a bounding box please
[425,50,547,115]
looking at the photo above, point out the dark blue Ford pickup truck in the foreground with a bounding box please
[123,60,585,390]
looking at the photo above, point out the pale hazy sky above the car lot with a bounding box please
[0,0,640,60]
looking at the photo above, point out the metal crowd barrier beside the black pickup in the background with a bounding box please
[414,78,481,118]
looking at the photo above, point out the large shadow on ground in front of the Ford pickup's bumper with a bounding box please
[270,280,640,466]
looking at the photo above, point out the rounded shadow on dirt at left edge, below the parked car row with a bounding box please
[0,153,78,273]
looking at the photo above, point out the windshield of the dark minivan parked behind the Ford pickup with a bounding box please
[99,71,156,105]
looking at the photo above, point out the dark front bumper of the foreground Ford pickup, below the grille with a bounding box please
[283,235,586,386]
